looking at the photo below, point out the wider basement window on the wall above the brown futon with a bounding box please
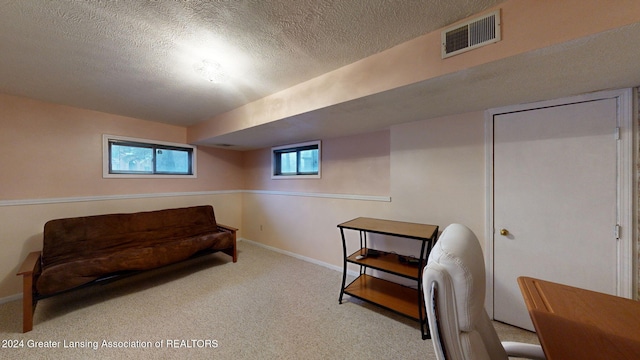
[102,135,196,178]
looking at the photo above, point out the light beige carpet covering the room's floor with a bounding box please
[0,241,537,359]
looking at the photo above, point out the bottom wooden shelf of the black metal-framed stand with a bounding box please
[344,274,421,321]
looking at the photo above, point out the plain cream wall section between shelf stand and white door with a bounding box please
[391,112,485,240]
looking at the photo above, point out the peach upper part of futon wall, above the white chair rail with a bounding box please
[0,94,243,201]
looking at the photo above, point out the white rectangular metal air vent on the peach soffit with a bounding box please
[442,10,500,59]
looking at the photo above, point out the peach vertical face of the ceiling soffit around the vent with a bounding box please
[187,0,640,148]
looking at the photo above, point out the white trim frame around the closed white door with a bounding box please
[484,89,638,318]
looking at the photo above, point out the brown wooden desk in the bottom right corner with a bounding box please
[518,277,640,360]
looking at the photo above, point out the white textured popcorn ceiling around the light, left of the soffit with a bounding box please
[0,0,501,126]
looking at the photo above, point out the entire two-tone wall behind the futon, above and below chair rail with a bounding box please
[0,94,244,299]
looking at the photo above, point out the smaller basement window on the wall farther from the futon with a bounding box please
[271,141,321,179]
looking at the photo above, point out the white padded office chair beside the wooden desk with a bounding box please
[422,224,545,360]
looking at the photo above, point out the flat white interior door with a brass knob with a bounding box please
[493,98,618,330]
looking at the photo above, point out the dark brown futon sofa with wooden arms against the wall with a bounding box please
[18,205,237,332]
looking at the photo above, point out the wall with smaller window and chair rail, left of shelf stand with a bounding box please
[242,131,390,266]
